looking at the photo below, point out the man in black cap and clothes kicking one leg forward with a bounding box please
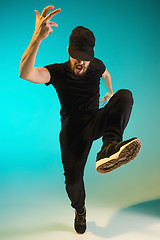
[19,6,141,234]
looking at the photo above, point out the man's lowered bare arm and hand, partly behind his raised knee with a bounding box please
[100,69,113,106]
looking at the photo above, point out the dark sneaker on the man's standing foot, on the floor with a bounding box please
[74,209,86,234]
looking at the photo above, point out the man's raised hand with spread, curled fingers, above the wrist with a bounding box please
[34,5,61,40]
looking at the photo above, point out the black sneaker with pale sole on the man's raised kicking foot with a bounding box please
[96,138,141,173]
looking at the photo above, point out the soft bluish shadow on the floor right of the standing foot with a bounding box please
[88,199,160,238]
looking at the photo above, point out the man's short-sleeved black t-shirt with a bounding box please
[45,58,105,118]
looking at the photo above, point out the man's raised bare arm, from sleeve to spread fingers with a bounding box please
[19,5,61,83]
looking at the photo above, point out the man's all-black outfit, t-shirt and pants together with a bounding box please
[46,59,133,211]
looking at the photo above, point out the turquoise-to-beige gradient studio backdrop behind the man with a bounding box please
[0,0,160,240]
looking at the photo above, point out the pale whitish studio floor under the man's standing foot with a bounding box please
[0,200,160,240]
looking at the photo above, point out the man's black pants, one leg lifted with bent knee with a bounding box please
[60,89,133,210]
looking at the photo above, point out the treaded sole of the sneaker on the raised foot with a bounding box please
[96,138,141,173]
